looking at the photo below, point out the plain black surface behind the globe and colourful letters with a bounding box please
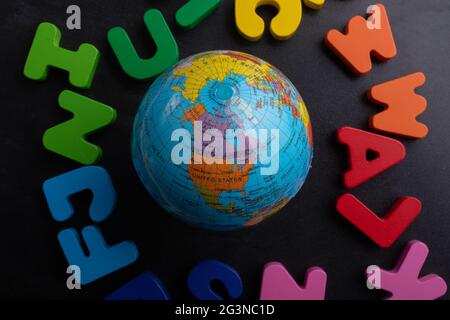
[0,0,450,299]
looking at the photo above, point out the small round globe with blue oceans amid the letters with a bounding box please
[132,51,313,230]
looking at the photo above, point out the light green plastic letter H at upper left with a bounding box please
[24,22,100,88]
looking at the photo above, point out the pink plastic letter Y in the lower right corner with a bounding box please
[368,240,447,300]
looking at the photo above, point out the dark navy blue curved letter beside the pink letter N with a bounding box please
[188,260,243,300]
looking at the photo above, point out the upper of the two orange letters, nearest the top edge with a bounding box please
[325,4,397,75]
